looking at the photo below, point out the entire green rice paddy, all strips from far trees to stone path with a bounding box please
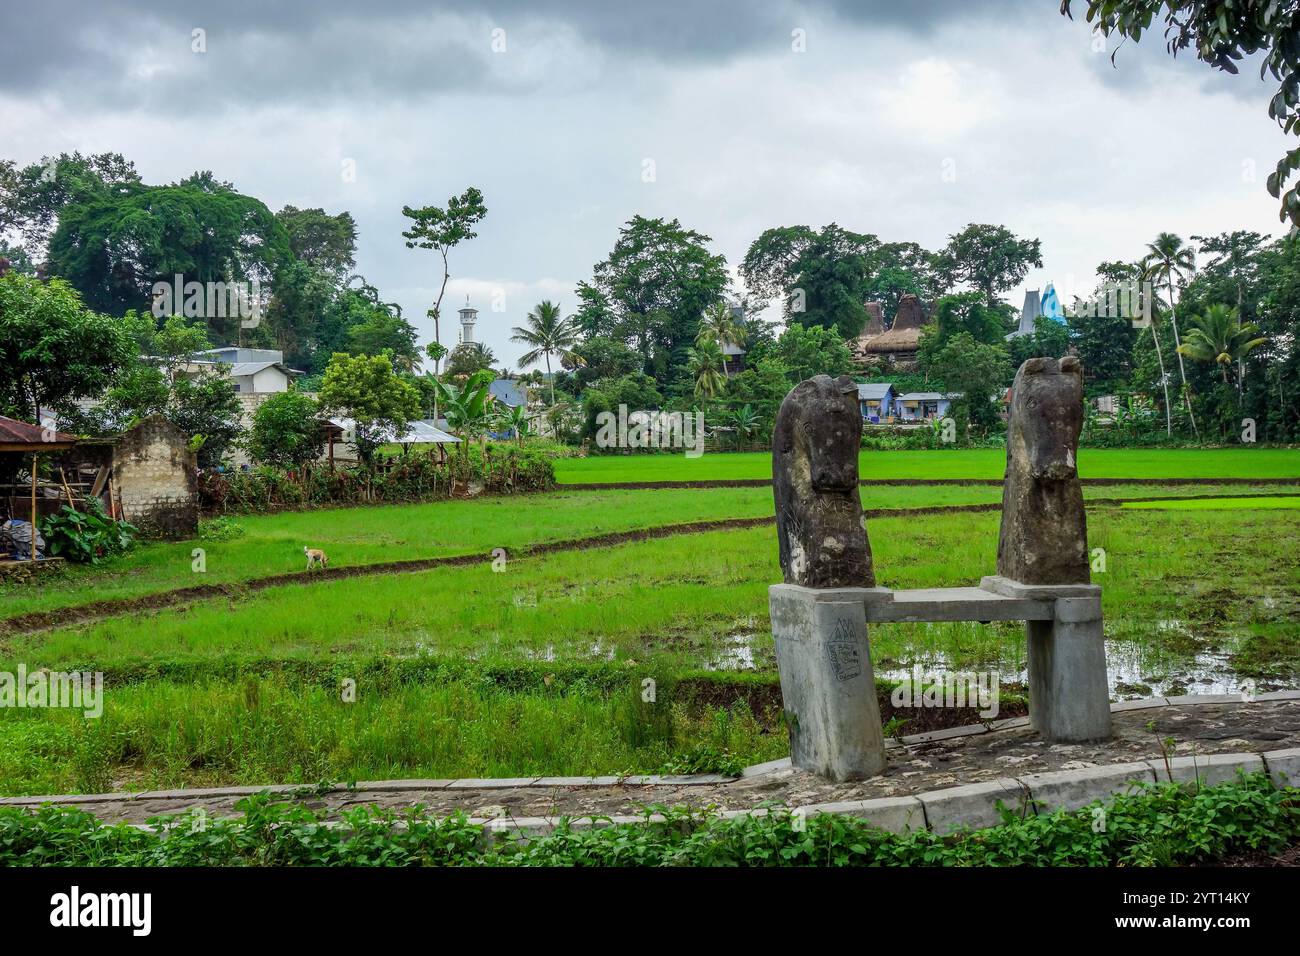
[0,449,1300,793]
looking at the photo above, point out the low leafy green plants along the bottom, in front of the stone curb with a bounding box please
[0,775,1300,866]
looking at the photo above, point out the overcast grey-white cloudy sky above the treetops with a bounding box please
[0,0,1287,362]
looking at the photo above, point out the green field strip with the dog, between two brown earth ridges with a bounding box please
[0,481,1300,620]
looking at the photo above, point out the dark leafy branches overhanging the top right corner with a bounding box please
[1061,0,1300,226]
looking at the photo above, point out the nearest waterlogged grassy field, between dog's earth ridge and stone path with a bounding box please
[0,509,1300,792]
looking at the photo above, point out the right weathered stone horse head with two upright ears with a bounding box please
[997,356,1089,584]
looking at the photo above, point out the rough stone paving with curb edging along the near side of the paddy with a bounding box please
[0,692,1300,826]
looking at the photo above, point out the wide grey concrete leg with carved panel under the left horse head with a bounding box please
[768,584,885,780]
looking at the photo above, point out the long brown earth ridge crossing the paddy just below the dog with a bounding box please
[0,483,1296,640]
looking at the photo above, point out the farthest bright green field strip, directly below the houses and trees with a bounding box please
[555,447,1300,484]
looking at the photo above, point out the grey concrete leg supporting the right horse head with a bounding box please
[1026,597,1110,743]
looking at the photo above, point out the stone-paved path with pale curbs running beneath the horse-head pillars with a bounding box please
[10,691,1300,831]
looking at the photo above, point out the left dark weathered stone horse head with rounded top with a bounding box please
[772,375,876,588]
